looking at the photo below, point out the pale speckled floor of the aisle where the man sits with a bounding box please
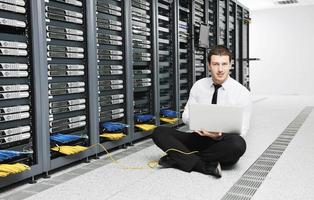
[0,96,314,200]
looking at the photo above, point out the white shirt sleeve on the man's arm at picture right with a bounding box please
[241,89,253,137]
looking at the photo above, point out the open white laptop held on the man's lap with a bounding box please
[189,104,244,134]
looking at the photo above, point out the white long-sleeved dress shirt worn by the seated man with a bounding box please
[182,76,252,136]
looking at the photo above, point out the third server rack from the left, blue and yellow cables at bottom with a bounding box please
[96,0,132,148]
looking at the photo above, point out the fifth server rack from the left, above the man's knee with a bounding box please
[156,0,178,126]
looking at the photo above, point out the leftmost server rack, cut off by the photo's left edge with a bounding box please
[0,0,36,165]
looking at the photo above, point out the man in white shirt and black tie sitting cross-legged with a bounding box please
[153,45,252,178]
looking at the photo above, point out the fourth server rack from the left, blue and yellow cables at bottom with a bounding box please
[131,0,159,140]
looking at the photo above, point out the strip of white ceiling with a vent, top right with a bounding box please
[238,0,314,10]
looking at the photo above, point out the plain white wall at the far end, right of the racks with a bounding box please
[250,6,314,95]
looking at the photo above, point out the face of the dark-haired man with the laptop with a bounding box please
[208,55,231,84]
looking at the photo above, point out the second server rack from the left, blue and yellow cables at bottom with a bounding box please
[41,0,95,174]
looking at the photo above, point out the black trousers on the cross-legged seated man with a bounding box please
[152,127,246,172]
